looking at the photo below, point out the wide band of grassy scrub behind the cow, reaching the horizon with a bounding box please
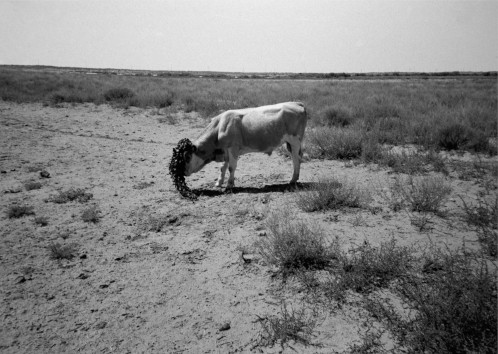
[0,68,498,155]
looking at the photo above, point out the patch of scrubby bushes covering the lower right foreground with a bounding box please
[259,206,497,353]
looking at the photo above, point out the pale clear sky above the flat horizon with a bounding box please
[0,0,498,72]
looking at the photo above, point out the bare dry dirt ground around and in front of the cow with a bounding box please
[0,101,494,353]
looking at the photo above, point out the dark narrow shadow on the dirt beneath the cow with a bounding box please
[192,182,316,197]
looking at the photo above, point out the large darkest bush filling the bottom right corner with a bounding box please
[368,250,497,354]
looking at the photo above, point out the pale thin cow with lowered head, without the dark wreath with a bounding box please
[185,102,307,188]
